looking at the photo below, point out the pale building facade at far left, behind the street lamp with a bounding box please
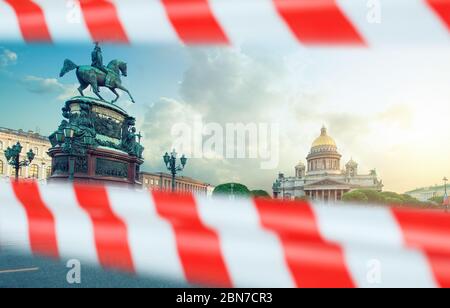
[0,128,52,181]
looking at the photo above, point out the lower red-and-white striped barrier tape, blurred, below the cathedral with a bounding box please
[0,183,450,287]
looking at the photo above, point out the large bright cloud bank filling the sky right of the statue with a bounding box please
[136,48,450,192]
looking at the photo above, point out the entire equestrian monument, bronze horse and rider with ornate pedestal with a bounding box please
[48,44,144,186]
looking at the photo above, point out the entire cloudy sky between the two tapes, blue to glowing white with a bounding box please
[0,45,450,192]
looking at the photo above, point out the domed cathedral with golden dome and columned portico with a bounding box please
[273,127,383,202]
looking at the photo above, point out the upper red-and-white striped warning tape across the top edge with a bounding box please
[0,0,450,46]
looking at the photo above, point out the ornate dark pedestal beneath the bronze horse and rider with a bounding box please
[48,97,144,186]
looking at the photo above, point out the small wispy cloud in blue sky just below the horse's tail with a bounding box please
[20,75,77,100]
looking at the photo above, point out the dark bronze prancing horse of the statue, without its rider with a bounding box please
[59,59,135,103]
